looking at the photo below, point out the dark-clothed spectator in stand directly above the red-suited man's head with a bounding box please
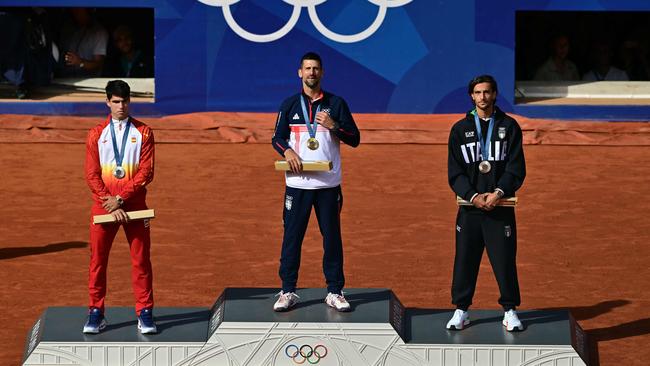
[104,25,153,78]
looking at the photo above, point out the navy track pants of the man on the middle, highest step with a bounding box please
[279,186,345,294]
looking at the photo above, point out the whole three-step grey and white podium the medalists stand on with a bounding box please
[23,288,588,366]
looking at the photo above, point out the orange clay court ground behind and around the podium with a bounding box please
[0,113,650,365]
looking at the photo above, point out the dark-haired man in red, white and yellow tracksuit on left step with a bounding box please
[84,80,155,333]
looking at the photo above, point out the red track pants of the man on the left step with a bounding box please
[88,206,153,314]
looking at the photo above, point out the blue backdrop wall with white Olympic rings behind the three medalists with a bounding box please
[0,0,650,117]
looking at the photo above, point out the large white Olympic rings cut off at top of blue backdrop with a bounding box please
[198,0,413,43]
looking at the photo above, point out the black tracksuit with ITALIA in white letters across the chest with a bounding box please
[448,108,526,310]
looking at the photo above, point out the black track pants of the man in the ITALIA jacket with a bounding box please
[451,207,521,310]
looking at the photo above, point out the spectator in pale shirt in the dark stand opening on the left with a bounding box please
[61,8,108,77]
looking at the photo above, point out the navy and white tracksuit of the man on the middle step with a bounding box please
[272,92,360,294]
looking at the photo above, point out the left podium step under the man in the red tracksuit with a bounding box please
[23,307,210,366]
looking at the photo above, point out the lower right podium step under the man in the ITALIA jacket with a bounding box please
[404,309,589,366]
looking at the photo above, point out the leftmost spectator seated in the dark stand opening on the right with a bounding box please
[535,34,580,81]
